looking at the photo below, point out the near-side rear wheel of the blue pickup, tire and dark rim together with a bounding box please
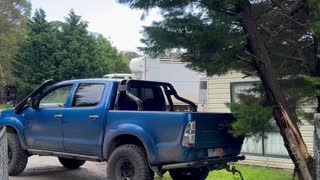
[107,144,153,180]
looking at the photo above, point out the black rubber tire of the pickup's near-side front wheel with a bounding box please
[7,133,29,176]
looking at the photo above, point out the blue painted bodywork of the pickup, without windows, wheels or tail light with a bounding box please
[0,79,243,165]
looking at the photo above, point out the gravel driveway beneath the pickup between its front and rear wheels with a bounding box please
[9,156,107,180]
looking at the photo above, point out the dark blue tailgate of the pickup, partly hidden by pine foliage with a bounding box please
[191,113,244,156]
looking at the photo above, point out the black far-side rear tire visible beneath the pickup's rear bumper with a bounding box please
[169,168,209,180]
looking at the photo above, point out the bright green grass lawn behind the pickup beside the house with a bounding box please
[156,165,292,180]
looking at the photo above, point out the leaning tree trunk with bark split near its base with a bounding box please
[240,0,315,180]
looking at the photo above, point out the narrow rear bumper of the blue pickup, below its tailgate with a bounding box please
[162,156,245,170]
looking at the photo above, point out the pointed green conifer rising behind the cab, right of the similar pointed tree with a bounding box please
[56,10,101,80]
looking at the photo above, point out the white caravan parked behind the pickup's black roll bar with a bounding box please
[130,57,207,111]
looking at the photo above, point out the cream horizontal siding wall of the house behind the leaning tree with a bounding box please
[208,72,313,169]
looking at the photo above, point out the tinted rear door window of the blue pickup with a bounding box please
[72,84,105,107]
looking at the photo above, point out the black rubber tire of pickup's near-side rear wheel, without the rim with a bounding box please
[107,144,154,180]
